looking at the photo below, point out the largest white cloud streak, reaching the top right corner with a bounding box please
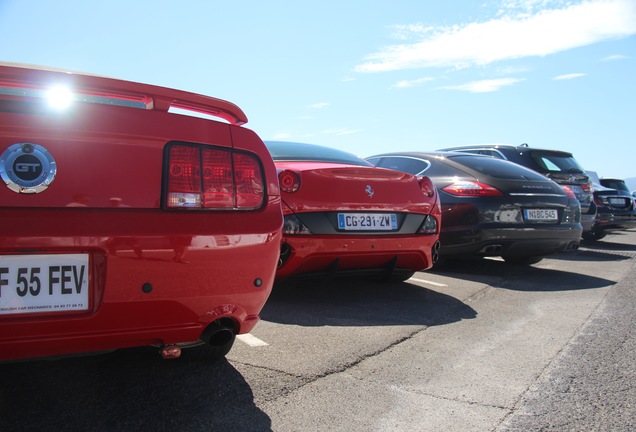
[355,0,636,72]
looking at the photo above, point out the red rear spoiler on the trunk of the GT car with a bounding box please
[0,63,247,126]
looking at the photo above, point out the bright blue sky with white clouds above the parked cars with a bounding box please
[0,0,636,182]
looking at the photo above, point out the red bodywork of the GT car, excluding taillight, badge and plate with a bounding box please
[0,66,282,360]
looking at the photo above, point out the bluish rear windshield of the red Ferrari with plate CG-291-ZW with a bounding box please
[265,141,373,166]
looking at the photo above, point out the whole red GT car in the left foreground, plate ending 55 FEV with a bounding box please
[0,65,283,360]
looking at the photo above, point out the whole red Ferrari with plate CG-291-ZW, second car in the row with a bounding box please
[265,141,441,281]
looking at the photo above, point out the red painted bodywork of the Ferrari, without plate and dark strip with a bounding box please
[268,157,441,281]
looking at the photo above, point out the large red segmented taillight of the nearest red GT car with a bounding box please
[166,145,265,209]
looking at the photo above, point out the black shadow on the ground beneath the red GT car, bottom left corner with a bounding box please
[0,349,271,431]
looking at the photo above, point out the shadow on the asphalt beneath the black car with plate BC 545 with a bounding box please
[433,255,616,292]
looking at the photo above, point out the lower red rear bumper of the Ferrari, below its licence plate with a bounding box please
[276,235,438,280]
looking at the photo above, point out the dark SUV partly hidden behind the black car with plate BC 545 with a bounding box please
[439,144,596,236]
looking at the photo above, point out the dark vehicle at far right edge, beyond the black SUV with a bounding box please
[583,178,636,240]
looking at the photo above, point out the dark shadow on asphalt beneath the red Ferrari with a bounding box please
[261,279,477,326]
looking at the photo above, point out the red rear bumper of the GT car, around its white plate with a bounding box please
[0,209,281,360]
